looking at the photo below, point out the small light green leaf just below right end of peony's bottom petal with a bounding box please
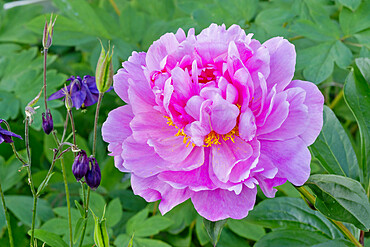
[227,219,265,241]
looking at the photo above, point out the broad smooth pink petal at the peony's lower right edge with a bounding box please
[260,137,311,186]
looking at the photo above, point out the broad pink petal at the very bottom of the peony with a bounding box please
[191,186,257,221]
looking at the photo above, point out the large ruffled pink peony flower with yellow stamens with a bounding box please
[102,24,324,221]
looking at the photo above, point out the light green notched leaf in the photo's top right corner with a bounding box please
[339,1,370,35]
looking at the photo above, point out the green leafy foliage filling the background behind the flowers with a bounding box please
[0,0,370,247]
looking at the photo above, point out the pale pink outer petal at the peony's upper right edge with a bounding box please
[263,37,296,92]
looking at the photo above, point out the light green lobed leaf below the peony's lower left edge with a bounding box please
[126,209,173,237]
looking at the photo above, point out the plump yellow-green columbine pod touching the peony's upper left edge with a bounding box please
[95,41,114,93]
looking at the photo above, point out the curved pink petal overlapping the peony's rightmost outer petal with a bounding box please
[258,88,309,141]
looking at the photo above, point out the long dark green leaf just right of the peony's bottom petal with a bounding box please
[247,197,342,239]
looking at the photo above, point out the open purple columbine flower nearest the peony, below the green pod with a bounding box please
[48,75,99,110]
